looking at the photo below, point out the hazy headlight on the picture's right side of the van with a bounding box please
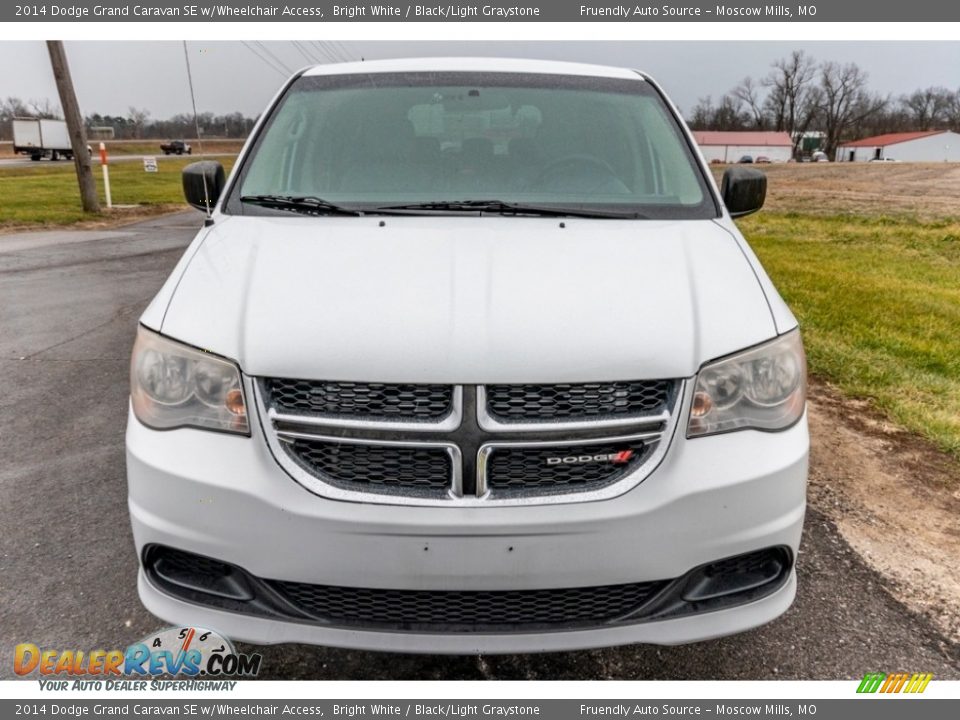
[687,330,807,438]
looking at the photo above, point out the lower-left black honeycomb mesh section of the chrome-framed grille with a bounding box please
[283,438,453,491]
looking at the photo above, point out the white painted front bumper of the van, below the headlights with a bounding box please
[127,404,809,653]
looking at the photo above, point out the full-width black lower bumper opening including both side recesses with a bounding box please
[142,545,793,633]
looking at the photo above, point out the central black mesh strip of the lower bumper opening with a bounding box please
[269,582,667,631]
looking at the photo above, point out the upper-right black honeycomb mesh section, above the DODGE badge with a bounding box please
[486,380,676,423]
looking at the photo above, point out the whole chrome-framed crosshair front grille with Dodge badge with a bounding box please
[255,379,684,505]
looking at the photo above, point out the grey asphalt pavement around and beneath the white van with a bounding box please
[0,213,960,679]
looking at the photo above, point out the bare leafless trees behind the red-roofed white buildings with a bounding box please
[687,50,960,157]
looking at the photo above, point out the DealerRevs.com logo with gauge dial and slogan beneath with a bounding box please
[13,627,263,690]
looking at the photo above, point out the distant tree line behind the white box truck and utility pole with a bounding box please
[0,97,255,141]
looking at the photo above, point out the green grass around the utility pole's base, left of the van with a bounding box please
[0,156,233,227]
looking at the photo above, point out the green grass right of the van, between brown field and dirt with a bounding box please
[740,212,960,458]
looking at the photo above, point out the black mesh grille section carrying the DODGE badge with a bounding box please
[486,441,656,491]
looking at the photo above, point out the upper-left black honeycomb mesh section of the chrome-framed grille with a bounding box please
[264,378,453,422]
